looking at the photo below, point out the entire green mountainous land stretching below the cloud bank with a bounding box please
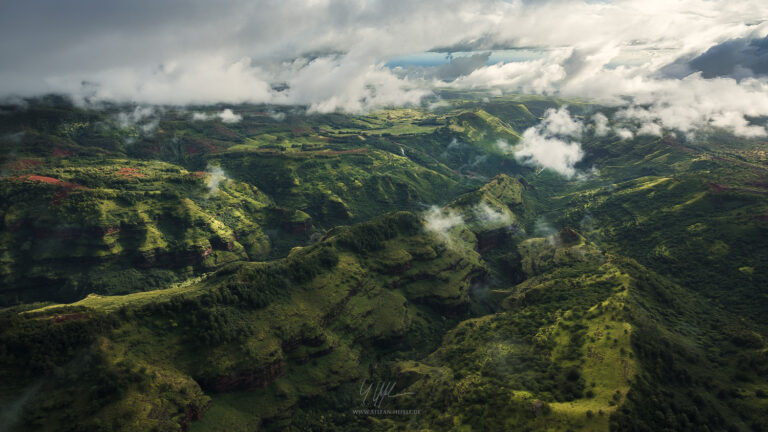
[0,90,768,432]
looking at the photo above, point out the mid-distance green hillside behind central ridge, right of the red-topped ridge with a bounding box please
[211,147,465,227]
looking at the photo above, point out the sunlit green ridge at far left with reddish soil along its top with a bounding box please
[0,159,312,305]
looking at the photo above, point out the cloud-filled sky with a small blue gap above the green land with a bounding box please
[0,0,768,137]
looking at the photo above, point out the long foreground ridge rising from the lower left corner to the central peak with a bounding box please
[0,213,487,430]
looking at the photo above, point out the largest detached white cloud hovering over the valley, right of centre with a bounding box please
[514,108,584,177]
